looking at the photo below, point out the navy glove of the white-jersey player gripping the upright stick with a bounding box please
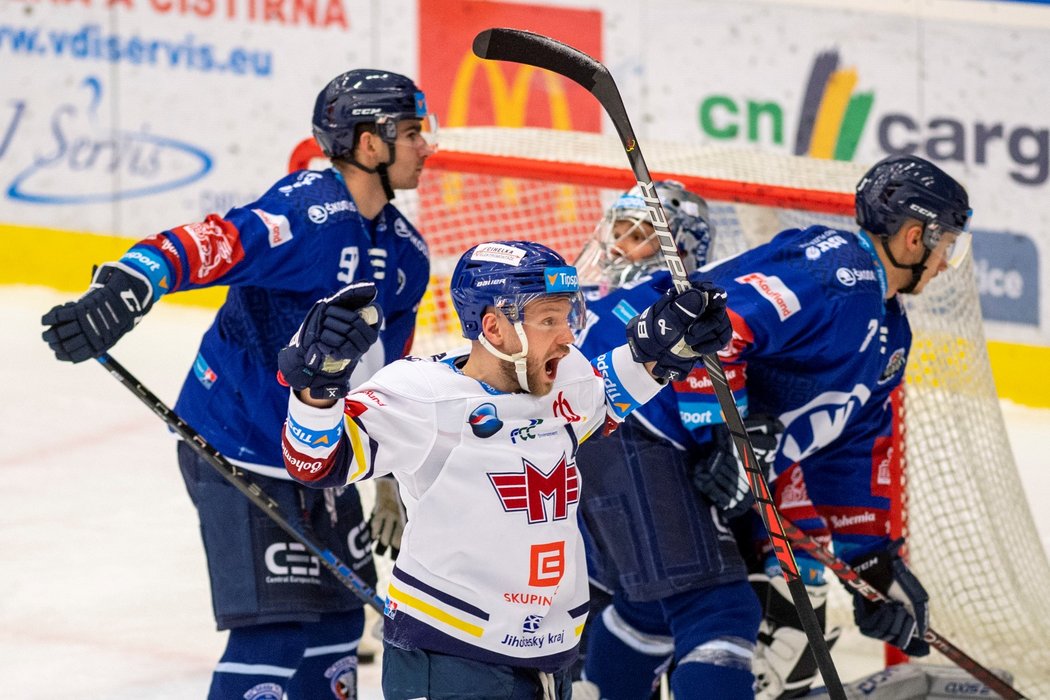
[627,281,733,381]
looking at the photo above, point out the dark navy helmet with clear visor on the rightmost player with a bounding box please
[856,155,972,267]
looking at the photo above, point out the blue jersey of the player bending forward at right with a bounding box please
[583,226,911,556]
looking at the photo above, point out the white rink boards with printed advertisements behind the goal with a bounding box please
[0,0,1050,392]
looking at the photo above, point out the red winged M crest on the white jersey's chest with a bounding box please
[487,454,580,525]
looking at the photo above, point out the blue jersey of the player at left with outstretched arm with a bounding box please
[114,169,429,479]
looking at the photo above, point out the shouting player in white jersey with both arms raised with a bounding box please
[280,241,730,700]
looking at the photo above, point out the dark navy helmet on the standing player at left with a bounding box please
[313,68,427,158]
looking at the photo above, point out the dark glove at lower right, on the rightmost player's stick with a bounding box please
[849,539,929,656]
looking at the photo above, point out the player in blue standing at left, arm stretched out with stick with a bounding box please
[43,69,433,700]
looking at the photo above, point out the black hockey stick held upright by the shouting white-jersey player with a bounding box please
[474,28,846,700]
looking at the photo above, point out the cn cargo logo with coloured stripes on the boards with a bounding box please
[698,50,1050,187]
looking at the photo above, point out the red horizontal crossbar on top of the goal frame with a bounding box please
[426,150,854,216]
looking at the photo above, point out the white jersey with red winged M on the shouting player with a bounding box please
[282,345,660,672]
